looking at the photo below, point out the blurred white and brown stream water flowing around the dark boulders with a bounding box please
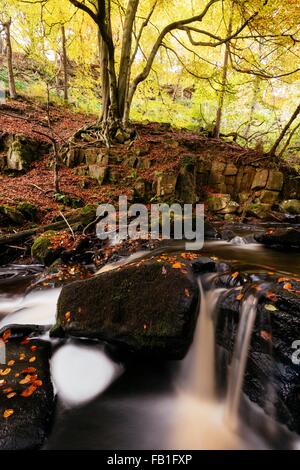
[0,240,300,450]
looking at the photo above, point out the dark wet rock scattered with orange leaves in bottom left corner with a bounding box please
[0,325,54,450]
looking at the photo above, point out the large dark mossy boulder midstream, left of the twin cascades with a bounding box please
[52,254,199,359]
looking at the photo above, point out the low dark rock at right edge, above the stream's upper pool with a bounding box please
[255,228,300,248]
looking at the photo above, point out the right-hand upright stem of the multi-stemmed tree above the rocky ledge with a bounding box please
[118,0,139,121]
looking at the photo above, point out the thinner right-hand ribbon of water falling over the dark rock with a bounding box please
[225,293,258,429]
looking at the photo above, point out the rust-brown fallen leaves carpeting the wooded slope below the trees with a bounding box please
[0,100,278,228]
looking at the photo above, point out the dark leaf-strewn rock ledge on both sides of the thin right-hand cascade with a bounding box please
[216,278,300,432]
